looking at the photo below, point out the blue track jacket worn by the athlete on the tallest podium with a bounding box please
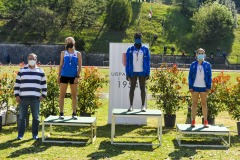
[125,46,150,77]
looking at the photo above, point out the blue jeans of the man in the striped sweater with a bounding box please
[18,98,40,137]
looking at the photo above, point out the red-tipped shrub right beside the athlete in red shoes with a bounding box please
[197,72,230,124]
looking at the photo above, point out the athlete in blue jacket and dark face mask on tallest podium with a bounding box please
[126,33,150,112]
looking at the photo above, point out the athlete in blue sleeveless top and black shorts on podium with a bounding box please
[58,37,82,119]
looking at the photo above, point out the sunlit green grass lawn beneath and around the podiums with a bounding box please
[0,66,240,160]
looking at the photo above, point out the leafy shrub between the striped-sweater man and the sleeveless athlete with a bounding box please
[40,66,59,118]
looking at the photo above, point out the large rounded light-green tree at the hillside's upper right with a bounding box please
[192,2,234,44]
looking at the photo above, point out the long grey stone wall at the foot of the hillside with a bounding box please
[0,44,240,69]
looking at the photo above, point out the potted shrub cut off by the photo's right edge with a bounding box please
[225,77,240,136]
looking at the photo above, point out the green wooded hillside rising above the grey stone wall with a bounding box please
[0,0,239,59]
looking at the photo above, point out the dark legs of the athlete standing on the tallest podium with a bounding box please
[129,75,146,106]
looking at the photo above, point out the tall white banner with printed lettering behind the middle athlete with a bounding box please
[108,43,149,125]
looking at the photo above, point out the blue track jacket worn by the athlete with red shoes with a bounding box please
[188,61,212,89]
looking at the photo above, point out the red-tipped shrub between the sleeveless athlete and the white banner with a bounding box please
[77,67,107,116]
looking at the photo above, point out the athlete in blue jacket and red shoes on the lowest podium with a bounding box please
[188,48,212,127]
